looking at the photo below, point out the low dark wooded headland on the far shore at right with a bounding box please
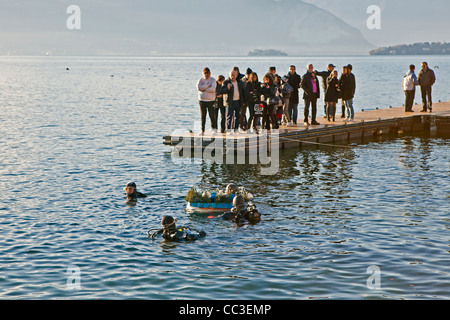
[369,42,450,55]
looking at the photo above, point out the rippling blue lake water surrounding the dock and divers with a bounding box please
[0,57,450,299]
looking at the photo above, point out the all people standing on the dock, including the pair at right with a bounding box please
[197,62,435,135]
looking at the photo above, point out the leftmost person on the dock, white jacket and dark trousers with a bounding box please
[197,68,217,135]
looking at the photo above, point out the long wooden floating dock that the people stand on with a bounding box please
[163,102,450,150]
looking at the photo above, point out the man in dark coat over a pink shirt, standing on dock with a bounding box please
[300,64,320,126]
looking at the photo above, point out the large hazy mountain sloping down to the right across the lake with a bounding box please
[0,0,375,56]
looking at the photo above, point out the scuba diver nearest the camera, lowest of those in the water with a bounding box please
[147,216,206,241]
